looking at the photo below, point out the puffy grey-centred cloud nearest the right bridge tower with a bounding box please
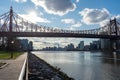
[79,8,110,25]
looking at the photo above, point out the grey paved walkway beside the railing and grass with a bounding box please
[0,53,26,80]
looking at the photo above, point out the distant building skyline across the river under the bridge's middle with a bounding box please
[39,40,100,51]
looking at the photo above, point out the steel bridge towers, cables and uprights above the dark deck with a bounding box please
[0,8,120,36]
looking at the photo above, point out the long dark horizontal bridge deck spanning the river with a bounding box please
[0,32,120,39]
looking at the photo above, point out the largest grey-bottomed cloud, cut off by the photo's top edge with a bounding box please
[31,0,76,16]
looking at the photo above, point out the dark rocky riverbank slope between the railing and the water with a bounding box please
[28,53,74,80]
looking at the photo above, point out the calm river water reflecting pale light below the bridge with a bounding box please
[33,51,120,80]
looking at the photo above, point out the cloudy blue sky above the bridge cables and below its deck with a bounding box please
[0,0,120,48]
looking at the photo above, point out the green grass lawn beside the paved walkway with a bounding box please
[0,51,23,59]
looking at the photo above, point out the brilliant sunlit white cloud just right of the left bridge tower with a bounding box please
[19,12,50,23]
